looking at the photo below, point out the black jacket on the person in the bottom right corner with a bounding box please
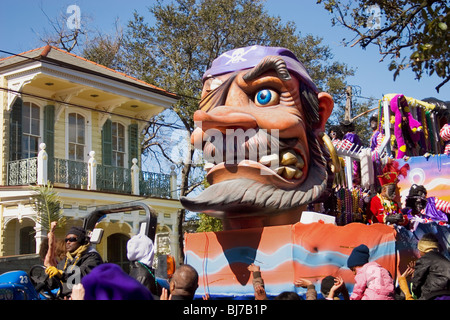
[411,251,450,300]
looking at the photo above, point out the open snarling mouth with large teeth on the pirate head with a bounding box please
[203,130,308,189]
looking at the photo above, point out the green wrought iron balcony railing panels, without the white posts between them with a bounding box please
[7,158,171,198]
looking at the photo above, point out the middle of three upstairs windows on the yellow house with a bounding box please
[69,113,86,161]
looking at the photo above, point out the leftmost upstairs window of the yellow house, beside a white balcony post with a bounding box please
[22,102,41,159]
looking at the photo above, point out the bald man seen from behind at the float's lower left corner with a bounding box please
[160,264,198,300]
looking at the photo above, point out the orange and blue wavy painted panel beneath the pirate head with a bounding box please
[185,223,396,299]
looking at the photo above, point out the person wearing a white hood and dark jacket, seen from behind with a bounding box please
[127,234,162,297]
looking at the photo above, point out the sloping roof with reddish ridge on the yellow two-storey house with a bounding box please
[0,45,179,99]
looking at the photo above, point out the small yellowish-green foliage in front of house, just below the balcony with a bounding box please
[33,184,66,231]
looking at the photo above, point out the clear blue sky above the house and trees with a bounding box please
[0,0,450,107]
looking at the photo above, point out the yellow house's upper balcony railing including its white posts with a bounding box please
[7,144,178,199]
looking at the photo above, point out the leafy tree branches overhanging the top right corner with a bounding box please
[317,0,450,92]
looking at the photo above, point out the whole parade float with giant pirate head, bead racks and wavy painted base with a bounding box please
[181,46,450,299]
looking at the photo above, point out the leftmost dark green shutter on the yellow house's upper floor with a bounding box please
[9,97,23,161]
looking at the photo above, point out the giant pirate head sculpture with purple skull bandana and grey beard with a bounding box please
[181,46,333,228]
